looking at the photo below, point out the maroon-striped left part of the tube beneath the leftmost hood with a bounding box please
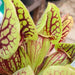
[0,50,21,73]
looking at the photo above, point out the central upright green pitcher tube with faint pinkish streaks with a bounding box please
[27,36,50,69]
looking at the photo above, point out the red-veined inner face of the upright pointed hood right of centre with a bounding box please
[39,7,62,43]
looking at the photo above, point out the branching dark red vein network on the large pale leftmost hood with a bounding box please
[0,9,16,54]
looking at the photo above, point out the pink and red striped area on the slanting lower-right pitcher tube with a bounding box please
[44,50,70,68]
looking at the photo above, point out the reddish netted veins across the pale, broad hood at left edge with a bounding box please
[0,9,16,49]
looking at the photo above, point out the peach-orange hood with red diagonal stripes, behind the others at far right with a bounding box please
[60,15,73,42]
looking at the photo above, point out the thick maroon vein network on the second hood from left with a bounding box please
[15,7,35,38]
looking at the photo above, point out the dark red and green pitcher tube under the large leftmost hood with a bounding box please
[0,47,31,74]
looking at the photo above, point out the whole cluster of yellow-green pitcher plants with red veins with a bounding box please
[0,0,75,75]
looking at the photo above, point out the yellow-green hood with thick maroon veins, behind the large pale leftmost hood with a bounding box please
[11,0,38,41]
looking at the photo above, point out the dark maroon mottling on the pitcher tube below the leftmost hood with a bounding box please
[0,48,21,73]
